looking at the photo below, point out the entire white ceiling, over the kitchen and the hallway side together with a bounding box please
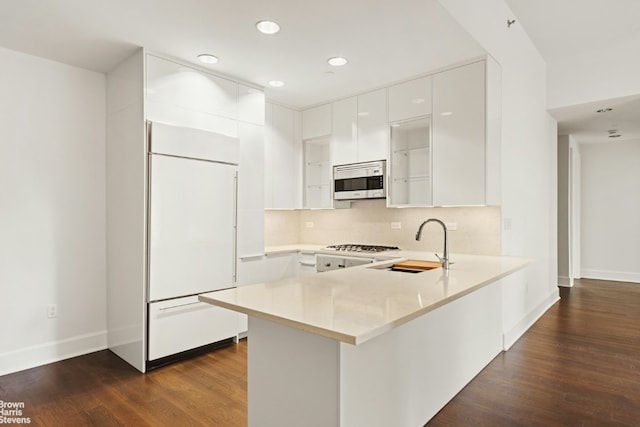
[0,0,640,141]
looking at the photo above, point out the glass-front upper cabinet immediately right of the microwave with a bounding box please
[387,116,432,207]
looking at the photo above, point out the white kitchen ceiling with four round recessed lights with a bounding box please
[0,0,484,107]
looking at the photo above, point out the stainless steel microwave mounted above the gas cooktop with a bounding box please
[333,160,387,200]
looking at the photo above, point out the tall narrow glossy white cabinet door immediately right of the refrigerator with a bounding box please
[238,122,265,257]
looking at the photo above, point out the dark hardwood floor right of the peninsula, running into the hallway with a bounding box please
[427,279,640,427]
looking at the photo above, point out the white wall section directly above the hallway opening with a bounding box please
[547,33,640,109]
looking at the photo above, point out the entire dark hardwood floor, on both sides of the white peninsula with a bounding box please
[0,280,640,427]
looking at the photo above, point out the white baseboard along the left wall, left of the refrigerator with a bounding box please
[0,331,107,375]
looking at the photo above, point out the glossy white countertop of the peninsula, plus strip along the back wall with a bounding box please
[200,252,530,345]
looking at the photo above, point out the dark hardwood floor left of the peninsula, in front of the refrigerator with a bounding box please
[0,340,247,427]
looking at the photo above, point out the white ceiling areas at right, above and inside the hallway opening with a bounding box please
[505,0,640,143]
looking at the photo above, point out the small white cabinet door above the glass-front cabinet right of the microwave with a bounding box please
[389,76,431,123]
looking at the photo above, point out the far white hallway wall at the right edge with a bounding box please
[580,140,640,282]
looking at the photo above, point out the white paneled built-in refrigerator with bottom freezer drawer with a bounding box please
[147,122,239,367]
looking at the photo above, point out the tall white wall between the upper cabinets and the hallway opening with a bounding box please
[439,0,558,348]
